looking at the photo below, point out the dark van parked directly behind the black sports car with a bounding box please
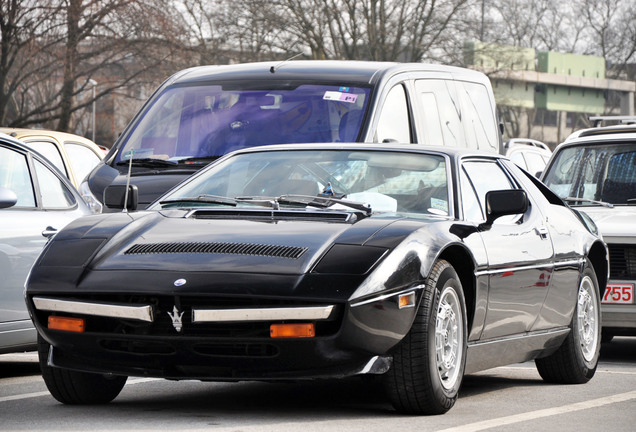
[80,61,502,212]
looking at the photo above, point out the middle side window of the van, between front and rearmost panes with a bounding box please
[415,79,465,147]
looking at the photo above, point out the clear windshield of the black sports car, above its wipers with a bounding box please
[154,149,449,216]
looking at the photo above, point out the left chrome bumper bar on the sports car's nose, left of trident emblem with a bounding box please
[33,297,154,322]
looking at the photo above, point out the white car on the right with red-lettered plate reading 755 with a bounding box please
[542,125,636,341]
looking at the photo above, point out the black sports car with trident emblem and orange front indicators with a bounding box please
[26,144,608,414]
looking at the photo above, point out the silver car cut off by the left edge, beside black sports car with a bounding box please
[0,133,90,353]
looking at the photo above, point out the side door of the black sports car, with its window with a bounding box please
[461,159,554,340]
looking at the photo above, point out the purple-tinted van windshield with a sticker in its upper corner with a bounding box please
[116,82,370,163]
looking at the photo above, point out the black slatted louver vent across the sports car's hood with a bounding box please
[124,242,307,259]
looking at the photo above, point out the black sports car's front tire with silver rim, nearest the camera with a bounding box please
[385,260,467,415]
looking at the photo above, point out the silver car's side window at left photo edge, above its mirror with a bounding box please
[0,148,35,208]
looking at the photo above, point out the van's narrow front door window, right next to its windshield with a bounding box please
[376,85,412,143]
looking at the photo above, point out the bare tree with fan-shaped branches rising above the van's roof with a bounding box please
[279,0,469,61]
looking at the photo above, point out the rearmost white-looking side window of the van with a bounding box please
[457,82,499,151]
